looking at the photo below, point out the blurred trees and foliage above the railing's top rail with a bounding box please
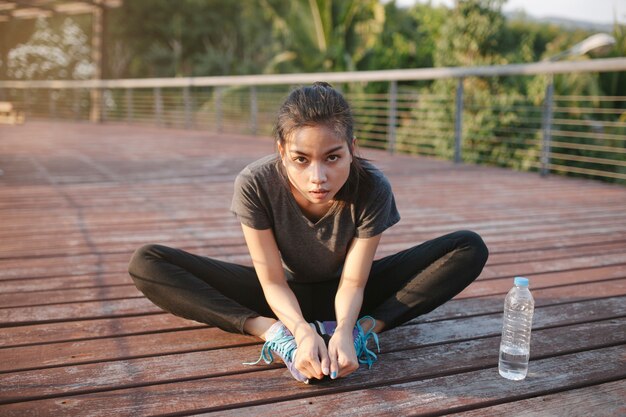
[0,0,626,83]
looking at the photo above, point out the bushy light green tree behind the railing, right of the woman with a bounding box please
[398,0,537,167]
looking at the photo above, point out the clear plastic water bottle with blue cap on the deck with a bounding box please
[498,277,535,381]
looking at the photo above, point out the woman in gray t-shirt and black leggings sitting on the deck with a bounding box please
[129,82,488,383]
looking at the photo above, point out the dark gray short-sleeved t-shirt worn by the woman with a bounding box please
[231,154,400,282]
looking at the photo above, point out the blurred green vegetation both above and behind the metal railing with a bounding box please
[0,0,626,182]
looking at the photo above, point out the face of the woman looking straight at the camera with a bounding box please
[278,125,352,215]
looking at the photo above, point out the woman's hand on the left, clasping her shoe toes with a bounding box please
[294,326,330,379]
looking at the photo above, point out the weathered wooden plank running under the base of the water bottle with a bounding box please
[210,346,626,417]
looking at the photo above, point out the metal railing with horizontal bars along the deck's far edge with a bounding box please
[0,58,626,183]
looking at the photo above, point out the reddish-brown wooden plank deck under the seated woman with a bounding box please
[0,122,626,417]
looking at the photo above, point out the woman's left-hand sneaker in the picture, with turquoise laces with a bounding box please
[243,321,309,384]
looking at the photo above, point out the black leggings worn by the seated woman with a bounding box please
[128,230,488,333]
